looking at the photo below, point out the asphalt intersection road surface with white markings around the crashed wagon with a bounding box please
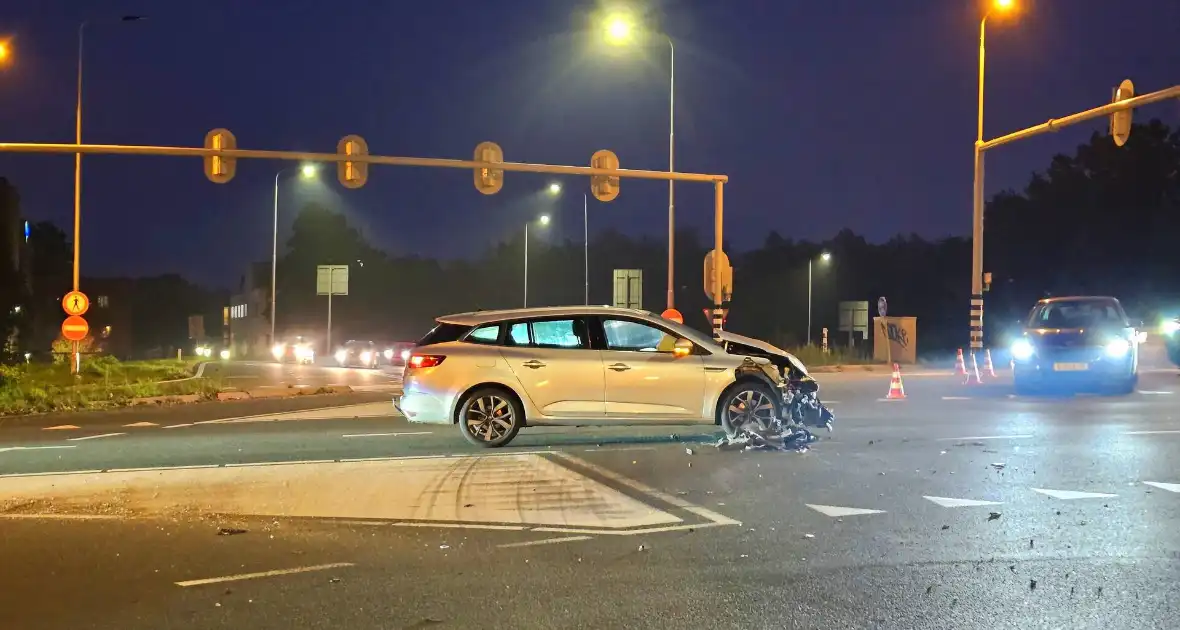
[0,369,1180,629]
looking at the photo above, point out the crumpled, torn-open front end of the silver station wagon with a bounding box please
[716,357,835,451]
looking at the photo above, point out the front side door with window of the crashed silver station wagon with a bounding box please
[599,317,704,420]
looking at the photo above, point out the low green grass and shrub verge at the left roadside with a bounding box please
[0,356,217,415]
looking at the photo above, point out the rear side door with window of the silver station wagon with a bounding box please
[500,316,605,419]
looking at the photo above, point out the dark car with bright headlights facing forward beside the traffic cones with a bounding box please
[1011,296,1140,394]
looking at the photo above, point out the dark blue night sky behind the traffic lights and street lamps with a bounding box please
[0,0,1180,286]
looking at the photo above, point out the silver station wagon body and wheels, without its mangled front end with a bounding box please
[394,307,786,447]
